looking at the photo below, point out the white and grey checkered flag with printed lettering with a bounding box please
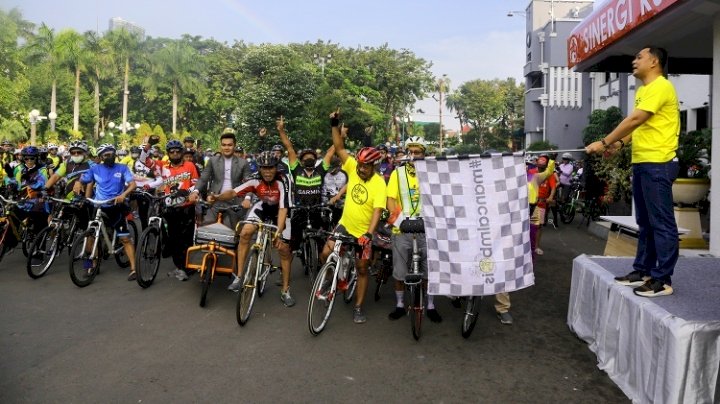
[415,153,535,296]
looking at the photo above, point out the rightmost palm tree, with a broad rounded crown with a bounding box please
[145,41,205,134]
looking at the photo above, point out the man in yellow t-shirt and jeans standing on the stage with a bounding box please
[585,47,680,297]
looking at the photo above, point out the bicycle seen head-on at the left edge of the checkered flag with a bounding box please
[400,217,425,341]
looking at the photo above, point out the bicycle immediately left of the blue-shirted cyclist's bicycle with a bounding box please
[26,197,79,279]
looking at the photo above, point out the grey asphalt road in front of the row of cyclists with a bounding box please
[0,225,628,403]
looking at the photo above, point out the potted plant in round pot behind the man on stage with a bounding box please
[673,129,712,205]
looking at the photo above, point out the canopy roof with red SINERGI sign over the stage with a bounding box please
[567,0,720,74]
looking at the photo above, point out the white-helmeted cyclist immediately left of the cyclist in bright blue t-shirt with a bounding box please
[45,140,95,229]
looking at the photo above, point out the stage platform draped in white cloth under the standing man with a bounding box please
[567,255,720,404]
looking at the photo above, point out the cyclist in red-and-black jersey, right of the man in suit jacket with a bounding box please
[214,151,295,307]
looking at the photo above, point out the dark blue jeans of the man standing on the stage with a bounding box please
[632,161,680,284]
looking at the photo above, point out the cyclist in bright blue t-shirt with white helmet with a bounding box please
[73,143,137,281]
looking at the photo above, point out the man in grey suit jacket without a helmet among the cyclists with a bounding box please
[190,128,251,228]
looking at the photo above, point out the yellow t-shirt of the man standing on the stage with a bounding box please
[632,76,680,164]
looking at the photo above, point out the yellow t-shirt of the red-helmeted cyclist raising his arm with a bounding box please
[339,157,387,237]
